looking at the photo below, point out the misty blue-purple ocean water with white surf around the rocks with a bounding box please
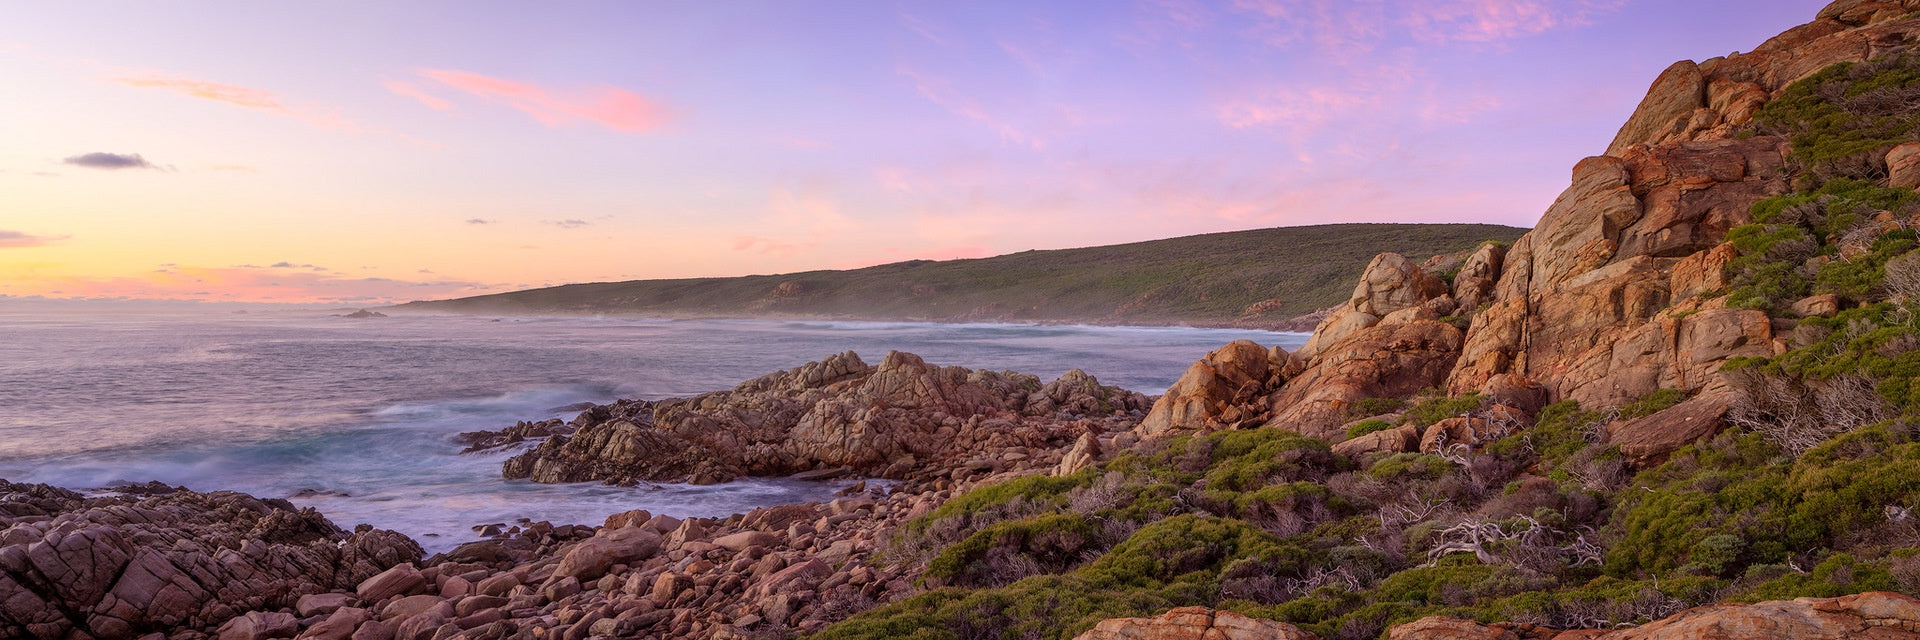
[0,307,1306,552]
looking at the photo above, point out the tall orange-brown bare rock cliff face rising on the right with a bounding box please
[1139,0,1920,455]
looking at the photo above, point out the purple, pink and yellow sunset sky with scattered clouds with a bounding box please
[0,0,1826,304]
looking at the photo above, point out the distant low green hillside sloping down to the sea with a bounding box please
[401,225,1524,327]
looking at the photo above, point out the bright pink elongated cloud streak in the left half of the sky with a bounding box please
[416,69,672,133]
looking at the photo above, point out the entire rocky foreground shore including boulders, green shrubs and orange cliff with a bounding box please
[11,0,1920,640]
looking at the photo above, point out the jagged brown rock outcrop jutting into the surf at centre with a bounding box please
[495,352,1148,482]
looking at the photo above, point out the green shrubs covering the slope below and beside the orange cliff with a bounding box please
[820,31,1920,638]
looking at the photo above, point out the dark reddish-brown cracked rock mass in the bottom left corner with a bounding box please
[0,480,420,640]
